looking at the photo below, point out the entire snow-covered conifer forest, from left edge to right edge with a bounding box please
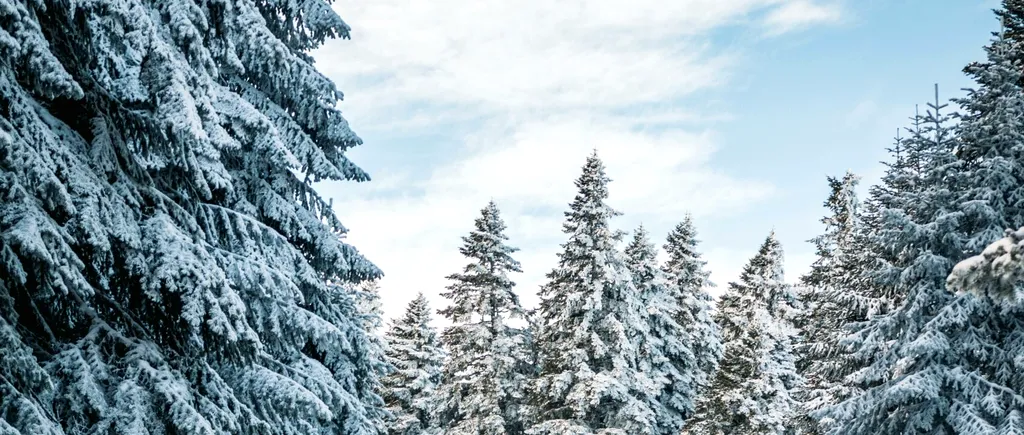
[6,0,1024,429]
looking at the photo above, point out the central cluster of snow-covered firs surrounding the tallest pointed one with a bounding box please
[382,151,729,435]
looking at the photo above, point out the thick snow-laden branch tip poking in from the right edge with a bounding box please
[946,228,1024,301]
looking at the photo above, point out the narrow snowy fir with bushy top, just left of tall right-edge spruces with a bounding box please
[794,172,869,434]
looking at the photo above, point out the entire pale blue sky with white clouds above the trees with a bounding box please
[314,0,998,318]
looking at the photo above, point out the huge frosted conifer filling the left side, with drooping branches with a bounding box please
[0,0,380,429]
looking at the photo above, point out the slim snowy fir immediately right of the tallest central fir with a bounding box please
[626,225,698,435]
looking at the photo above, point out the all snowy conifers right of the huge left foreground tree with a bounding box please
[376,0,1024,435]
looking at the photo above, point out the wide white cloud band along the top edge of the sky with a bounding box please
[315,0,839,123]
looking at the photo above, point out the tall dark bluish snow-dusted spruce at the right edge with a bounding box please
[833,15,1024,425]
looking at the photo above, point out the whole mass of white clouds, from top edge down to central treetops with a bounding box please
[314,0,847,316]
